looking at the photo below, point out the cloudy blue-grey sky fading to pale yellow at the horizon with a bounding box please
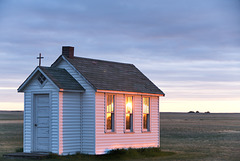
[0,0,240,113]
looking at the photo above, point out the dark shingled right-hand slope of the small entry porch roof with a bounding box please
[39,66,84,90]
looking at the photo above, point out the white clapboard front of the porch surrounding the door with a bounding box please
[23,78,58,153]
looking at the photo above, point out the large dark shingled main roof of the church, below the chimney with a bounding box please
[52,56,164,95]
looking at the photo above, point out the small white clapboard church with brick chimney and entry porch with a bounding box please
[18,46,164,155]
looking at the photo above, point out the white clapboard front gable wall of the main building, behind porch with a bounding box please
[56,60,95,154]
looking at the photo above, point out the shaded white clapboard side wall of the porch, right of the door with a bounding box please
[59,92,82,155]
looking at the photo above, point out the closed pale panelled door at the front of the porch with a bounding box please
[33,94,51,152]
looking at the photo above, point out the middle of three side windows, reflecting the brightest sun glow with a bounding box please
[126,97,133,131]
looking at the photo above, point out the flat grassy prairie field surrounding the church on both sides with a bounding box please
[0,112,240,161]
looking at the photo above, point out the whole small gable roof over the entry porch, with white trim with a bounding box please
[18,66,85,92]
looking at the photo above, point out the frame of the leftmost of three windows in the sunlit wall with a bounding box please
[105,94,116,133]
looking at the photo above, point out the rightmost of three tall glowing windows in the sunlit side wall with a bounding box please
[143,97,150,131]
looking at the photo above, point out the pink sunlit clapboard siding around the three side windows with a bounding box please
[96,93,159,154]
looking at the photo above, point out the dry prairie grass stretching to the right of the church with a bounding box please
[161,113,240,161]
